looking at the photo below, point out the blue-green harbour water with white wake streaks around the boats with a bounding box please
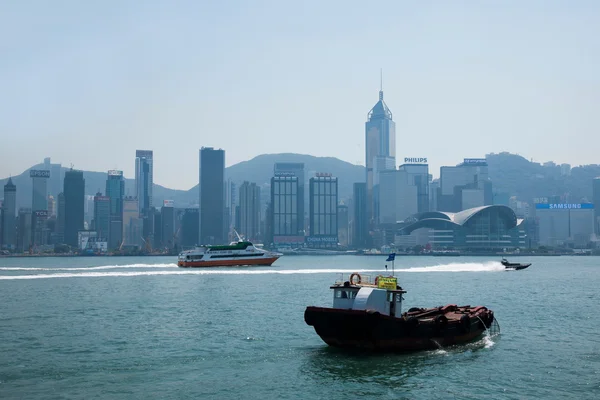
[0,256,600,399]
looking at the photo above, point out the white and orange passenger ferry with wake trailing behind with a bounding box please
[177,232,282,267]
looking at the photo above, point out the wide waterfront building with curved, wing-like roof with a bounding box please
[402,205,525,249]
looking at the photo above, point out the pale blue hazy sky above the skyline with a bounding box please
[0,0,600,189]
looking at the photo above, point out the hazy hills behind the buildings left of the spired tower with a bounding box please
[0,153,365,207]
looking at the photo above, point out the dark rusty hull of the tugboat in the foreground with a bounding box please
[304,307,494,352]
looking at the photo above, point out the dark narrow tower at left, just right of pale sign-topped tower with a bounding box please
[63,169,85,247]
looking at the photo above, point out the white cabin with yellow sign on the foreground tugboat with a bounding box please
[331,274,406,317]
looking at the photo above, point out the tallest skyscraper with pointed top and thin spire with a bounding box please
[365,79,396,221]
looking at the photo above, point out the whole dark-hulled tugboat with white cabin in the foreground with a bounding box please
[304,273,499,352]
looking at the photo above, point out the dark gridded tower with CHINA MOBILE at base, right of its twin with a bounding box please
[306,173,338,248]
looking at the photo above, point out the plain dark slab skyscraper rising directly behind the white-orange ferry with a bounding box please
[198,147,226,244]
